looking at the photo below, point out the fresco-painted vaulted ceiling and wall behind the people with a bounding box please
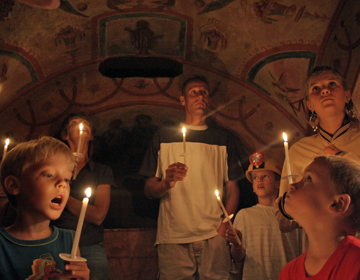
[0,0,360,226]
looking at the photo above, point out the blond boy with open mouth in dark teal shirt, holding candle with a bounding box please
[0,137,89,279]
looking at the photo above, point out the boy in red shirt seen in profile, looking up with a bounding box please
[279,155,360,280]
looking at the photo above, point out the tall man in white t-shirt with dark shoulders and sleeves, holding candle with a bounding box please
[140,76,243,280]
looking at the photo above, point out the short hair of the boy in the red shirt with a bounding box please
[314,155,360,232]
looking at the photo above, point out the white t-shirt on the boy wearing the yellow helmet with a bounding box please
[234,204,302,280]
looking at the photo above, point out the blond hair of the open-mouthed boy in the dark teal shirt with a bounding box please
[0,136,75,207]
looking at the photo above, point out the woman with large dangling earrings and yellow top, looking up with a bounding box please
[275,66,360,232]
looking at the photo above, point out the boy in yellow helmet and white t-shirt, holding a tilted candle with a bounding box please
[226,153,301,280]
